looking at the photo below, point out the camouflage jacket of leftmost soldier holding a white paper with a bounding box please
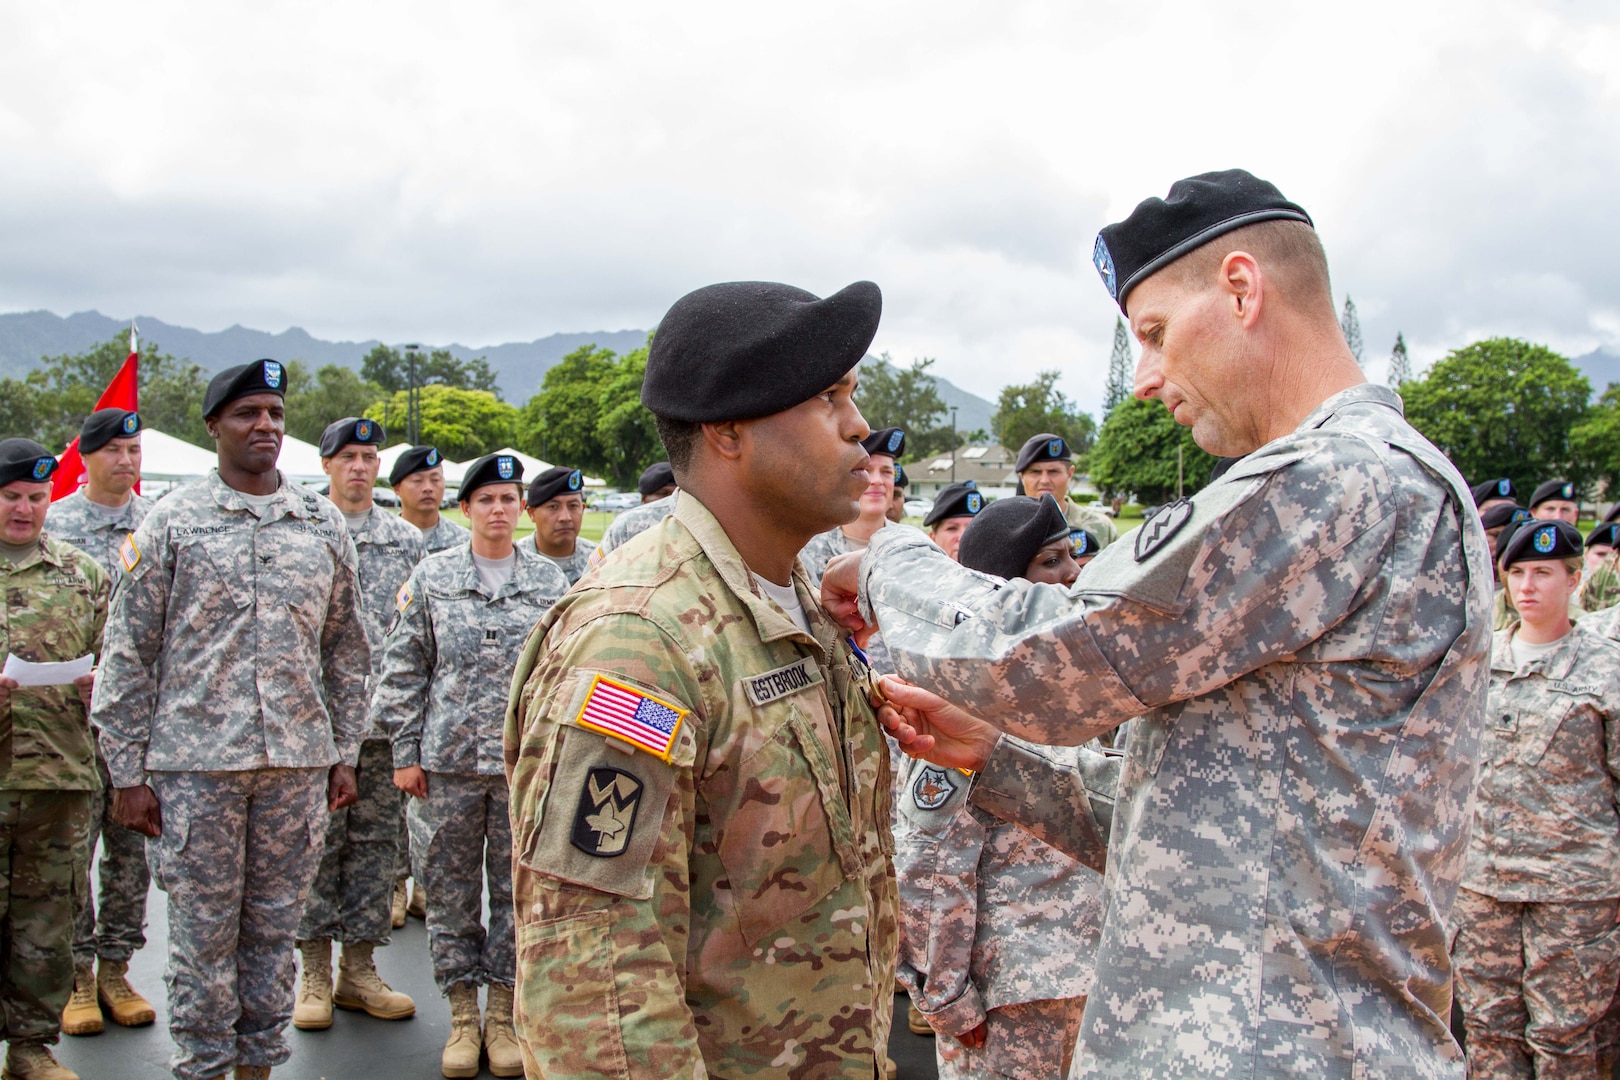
[0,534,110,792]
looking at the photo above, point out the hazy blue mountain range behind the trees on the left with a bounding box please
[0,311,995,431]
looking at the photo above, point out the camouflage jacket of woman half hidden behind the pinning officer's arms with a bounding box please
[894,746,1103,1035]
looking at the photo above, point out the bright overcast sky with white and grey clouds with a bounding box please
[0,0,1620,408]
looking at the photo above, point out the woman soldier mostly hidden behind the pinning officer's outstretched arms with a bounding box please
[894,495,1103,1080]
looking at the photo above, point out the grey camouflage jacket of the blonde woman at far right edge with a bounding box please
[1463,623,1620,904]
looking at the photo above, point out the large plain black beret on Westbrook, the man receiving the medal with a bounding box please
[642,282,883,424]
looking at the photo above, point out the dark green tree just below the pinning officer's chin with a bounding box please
[1090,397,1215,505]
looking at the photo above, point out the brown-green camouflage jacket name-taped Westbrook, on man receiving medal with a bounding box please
[505,492,897,1080]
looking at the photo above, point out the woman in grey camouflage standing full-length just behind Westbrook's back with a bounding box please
[371,453,569,1077]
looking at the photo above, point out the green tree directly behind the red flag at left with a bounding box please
[25,334,214,452]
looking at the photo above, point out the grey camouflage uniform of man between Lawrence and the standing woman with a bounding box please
[298,507,428,944]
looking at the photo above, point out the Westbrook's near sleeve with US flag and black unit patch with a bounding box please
[507,615,706,1080]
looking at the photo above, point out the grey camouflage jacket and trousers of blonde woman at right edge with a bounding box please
[1452,630,1620,1080]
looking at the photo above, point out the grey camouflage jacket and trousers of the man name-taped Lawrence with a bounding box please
[94,471,371,1080]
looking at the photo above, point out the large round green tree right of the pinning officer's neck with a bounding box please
[1401,337,1594,489]
